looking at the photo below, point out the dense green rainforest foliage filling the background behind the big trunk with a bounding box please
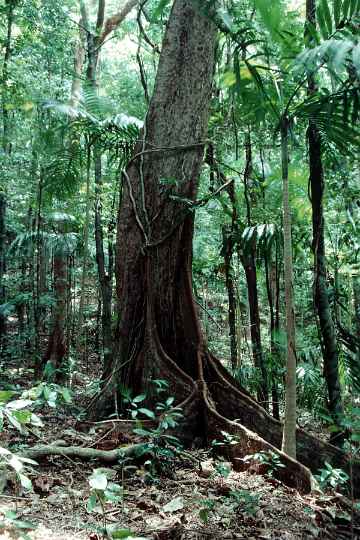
[0,0,360,452]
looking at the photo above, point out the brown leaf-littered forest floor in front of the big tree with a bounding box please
[0,360,360,540]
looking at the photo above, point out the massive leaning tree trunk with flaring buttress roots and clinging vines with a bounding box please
[93,0,359,491]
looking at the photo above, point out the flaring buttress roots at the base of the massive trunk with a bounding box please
[90,285,360,495]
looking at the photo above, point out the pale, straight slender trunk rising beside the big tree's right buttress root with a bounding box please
[281,118,296,459]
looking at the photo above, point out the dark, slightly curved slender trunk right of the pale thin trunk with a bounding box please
[306,0,343,444]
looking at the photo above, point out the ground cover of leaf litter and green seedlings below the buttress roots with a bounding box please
[0,357,360,540]
